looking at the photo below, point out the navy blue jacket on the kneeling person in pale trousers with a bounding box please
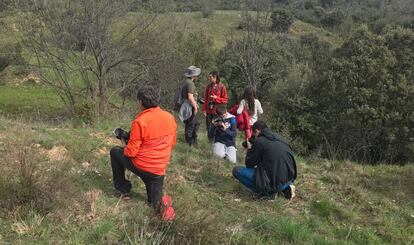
[214,112,237,147]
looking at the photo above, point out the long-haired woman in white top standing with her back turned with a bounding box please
[237,86,263,139]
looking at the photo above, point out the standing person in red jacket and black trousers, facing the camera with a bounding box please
[202,71,228,142]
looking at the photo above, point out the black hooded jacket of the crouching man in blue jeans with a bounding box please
[246,128,296,193]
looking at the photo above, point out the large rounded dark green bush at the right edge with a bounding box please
[307,27,414,163]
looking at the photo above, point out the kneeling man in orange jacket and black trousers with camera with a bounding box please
[110,87,177,219]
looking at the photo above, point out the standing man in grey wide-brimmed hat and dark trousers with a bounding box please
[180,66,201,146]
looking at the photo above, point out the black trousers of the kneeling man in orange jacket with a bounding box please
[110,146,164,207]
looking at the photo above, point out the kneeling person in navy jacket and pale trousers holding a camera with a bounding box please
[212,104,237,163]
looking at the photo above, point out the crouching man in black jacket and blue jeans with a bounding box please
[233,121,296,200]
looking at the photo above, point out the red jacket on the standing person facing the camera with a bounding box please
[202,82,228,114]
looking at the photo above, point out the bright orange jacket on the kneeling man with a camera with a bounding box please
[124,107,177,175]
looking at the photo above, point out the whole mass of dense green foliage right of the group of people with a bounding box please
[269,27,414,163]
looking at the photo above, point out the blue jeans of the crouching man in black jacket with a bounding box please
[233,167,292,195]
